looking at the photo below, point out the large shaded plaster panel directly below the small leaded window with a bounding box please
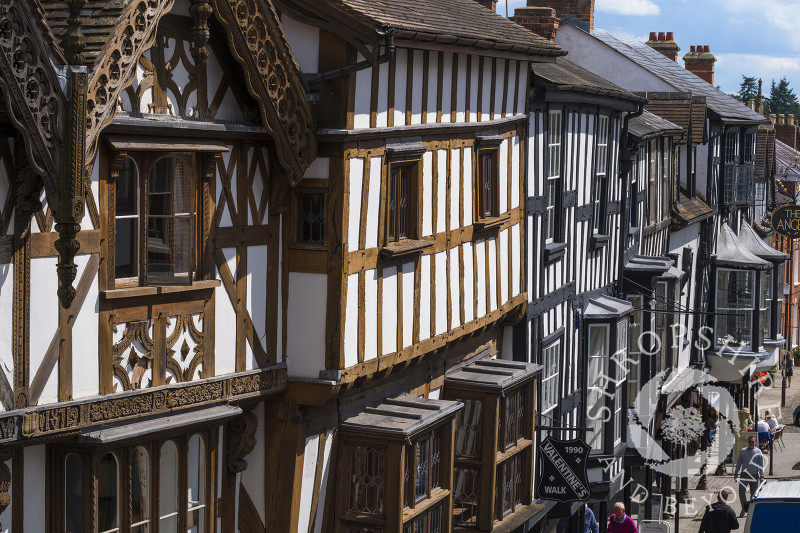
[286,272,328,378]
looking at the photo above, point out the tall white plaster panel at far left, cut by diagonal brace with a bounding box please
[30,257,58,404]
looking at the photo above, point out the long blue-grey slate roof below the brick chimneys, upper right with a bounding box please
[591,30,767,122]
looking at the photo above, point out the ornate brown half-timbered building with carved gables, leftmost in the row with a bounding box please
[0,0,316,532]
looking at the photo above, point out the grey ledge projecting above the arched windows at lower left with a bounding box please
[78,404,242,444]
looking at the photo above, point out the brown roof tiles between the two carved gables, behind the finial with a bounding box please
[41,0,130,62]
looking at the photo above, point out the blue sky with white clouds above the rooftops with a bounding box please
[497,0,800,97]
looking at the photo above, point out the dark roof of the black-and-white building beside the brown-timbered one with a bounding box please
[531,57,645,102]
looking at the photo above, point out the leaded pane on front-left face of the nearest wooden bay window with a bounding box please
[349,446,384,515]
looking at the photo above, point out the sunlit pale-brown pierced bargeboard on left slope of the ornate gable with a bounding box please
[84,0,173,166]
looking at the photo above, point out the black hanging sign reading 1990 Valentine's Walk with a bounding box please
[537,437,590,502]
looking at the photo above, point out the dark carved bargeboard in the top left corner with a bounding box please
[0,0,66,199]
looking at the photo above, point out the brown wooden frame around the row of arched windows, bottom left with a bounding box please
[52,426,219,533]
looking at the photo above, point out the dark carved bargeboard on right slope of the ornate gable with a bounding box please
[214,0,317,186]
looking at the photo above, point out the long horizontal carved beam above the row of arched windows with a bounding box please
[7,367,286,442]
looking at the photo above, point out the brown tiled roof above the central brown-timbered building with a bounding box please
[336,0,566,56]
